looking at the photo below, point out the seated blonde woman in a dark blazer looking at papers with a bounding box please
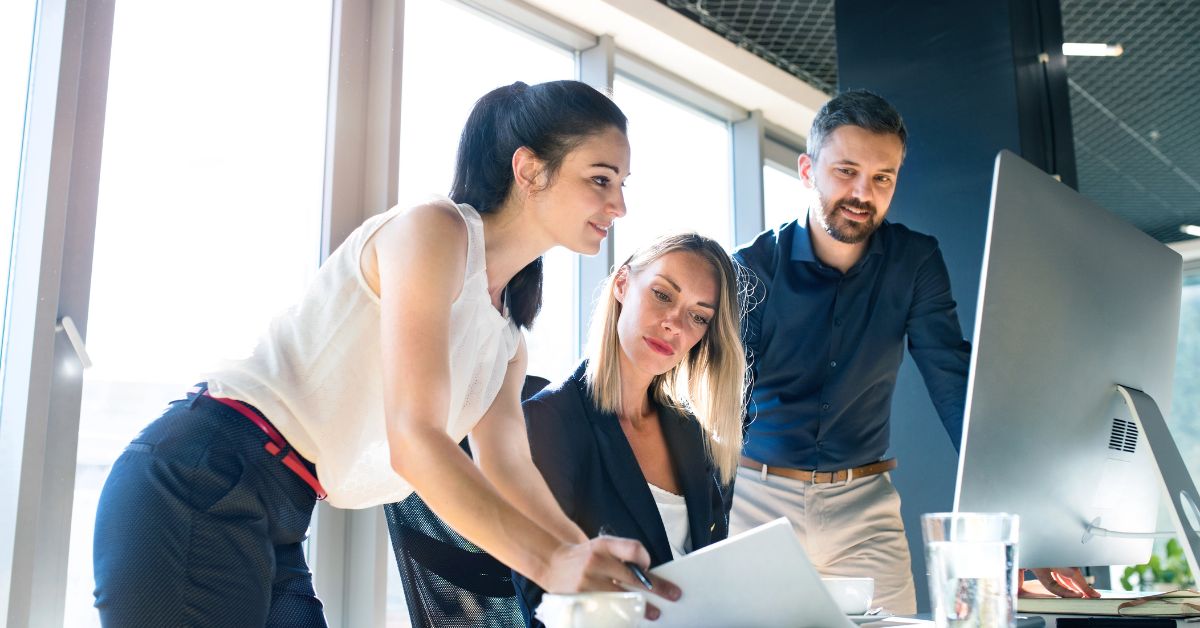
[517,233,746,622]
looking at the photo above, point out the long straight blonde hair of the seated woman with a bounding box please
[587,233,746,484]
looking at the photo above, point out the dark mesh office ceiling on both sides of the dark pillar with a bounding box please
[659,0,1200,243]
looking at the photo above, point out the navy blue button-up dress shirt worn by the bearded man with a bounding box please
[733,217,971,471]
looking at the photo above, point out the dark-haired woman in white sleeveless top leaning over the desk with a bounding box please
[94,80,678,627]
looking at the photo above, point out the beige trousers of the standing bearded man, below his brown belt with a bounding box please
[730,467,917,615]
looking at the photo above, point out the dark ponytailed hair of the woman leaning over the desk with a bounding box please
[450,80,625,328]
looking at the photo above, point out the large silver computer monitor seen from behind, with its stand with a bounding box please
[954,151,1200,573]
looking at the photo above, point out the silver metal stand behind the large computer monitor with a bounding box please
[1084,384,1200,580]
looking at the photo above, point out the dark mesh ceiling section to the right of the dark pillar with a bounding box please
[1061,0,1200,243]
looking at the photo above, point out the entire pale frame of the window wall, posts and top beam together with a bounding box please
[0,0,816,628]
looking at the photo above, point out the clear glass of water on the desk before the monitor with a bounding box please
[920,513,1020,628]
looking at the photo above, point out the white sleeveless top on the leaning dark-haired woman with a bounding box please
[208,199,521,508]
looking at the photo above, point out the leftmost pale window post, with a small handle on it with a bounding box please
[0,0,114,626]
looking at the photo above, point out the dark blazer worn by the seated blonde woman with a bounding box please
[514,361,730,626]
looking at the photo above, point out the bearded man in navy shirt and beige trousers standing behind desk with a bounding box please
[730,90,971,615]
